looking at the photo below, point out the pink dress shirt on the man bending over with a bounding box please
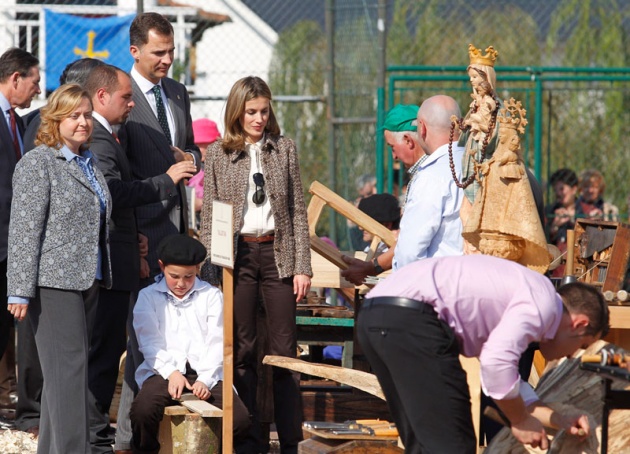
[367,255,562,404]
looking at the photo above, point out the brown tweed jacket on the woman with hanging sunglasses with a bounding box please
[201,135,313,285]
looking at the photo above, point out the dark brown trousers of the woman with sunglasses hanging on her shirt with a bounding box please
[234,242,302,454]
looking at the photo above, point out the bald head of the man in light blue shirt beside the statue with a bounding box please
[418,95,461,154]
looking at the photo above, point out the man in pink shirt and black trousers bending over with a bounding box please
[357,255,609,454]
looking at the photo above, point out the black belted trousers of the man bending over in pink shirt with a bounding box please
[357,305,477,454]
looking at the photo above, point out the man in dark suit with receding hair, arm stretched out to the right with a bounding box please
[85,65,196,454]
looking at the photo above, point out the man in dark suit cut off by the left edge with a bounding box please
[0,48,40,418]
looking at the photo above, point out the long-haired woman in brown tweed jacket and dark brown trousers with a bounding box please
[201,76,312,453]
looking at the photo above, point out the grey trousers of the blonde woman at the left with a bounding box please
[28,281,98,454]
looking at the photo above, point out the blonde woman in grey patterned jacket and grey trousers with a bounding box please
[7,85,112,454]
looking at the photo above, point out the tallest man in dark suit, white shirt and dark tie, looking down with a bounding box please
[115,13,201,452]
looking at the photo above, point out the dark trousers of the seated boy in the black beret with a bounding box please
[130,375,252,454]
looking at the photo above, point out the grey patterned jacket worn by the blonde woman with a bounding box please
[7,145,112,298]
